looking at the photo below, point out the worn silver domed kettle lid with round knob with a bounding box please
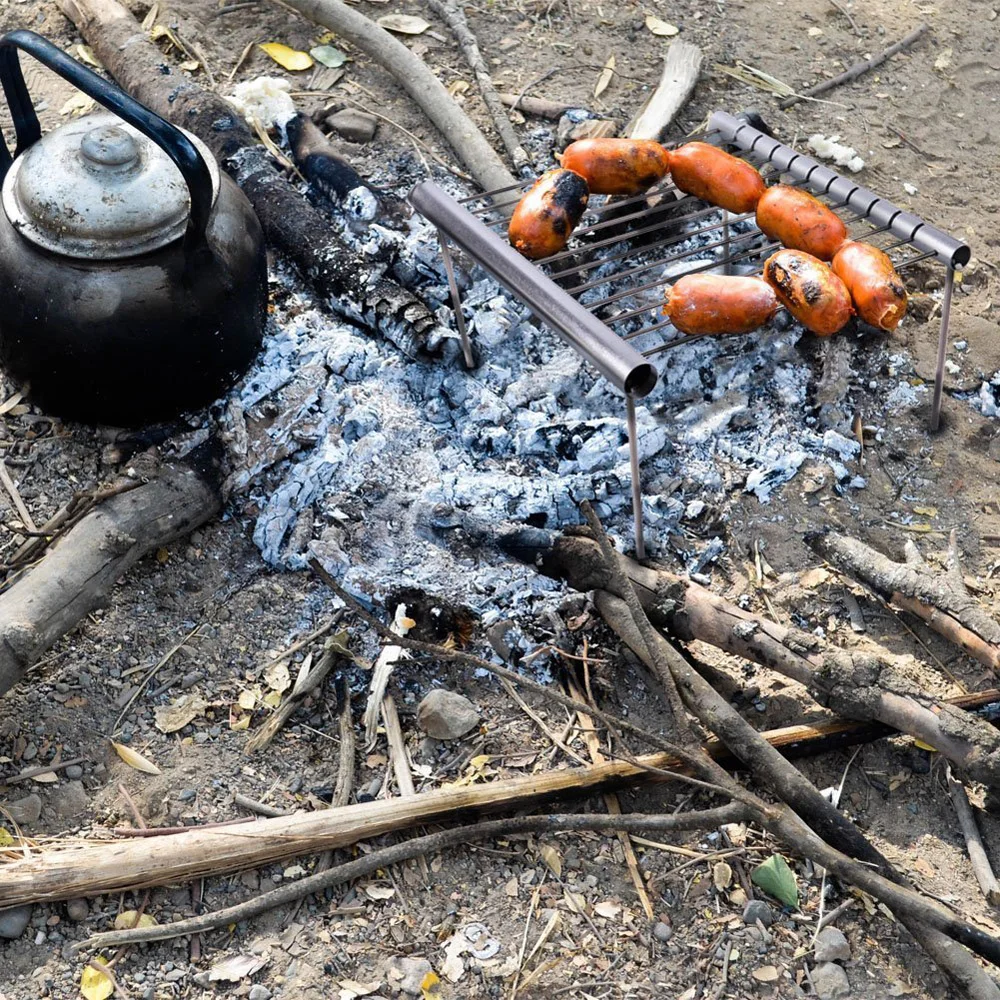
[2,112,219,260]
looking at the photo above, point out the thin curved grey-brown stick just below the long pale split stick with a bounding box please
[74,803,747,951]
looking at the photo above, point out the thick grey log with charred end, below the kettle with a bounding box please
[0,464,222,694]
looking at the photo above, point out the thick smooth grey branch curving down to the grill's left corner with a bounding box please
[274,0,517,191]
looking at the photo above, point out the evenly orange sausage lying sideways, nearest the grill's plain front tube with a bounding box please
[663,274,778,335]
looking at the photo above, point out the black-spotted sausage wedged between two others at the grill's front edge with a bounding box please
[764,250,854,337]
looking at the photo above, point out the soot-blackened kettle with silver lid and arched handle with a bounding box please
[0,31,267,427]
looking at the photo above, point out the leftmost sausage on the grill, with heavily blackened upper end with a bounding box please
[507,170,590,260]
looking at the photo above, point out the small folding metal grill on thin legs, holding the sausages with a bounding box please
[410,111,971,558]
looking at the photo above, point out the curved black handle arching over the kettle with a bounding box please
[0,29,214,240]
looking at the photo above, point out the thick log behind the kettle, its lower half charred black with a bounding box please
[58,0,444,357]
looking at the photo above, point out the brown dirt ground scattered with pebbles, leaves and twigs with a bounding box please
[0,0,1000,1000]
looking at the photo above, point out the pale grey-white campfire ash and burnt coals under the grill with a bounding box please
[221,166,936,613]
